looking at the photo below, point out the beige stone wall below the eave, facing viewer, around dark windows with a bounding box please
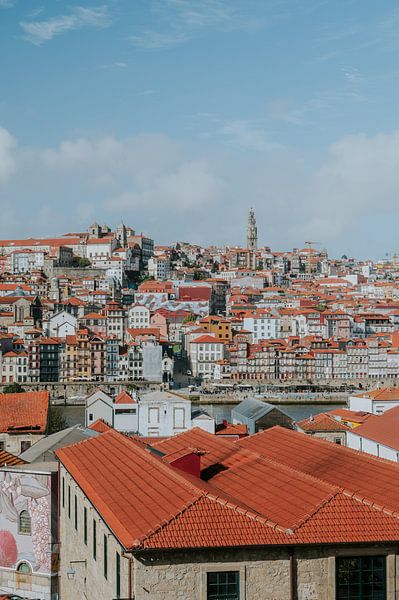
[134,546,399,600]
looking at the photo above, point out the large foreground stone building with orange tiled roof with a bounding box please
[57,427,399,600]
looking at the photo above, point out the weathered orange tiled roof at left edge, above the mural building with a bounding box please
[0,392,49,433]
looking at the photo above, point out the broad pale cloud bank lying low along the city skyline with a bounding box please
[0,128,399,255]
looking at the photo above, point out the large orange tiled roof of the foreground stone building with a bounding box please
[57,427,399,550]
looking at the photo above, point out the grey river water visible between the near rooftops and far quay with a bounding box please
[62,403,345,427]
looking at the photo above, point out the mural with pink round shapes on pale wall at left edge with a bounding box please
[0,471,51,573]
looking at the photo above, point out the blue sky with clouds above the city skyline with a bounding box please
[0,0,399,258]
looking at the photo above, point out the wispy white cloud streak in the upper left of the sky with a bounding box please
[19,6,111,46]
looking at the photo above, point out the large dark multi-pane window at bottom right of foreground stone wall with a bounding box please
[336,556,387,600]
